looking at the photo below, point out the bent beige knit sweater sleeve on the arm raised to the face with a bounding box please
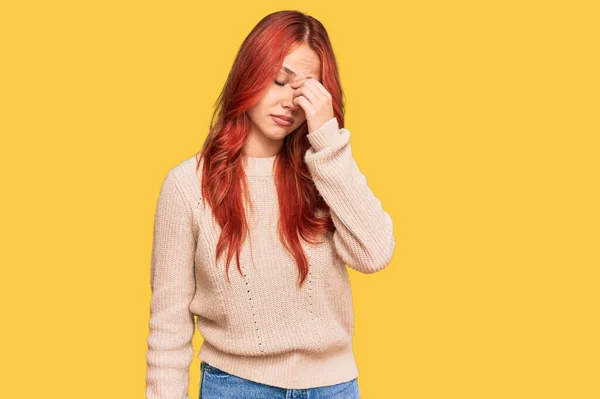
[304,117,396,273]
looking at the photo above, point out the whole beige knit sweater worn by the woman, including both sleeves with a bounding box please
[146,118,395,399]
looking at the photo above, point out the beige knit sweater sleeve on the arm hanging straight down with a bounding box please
[146,170,196,399]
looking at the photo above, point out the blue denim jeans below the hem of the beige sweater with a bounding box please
[199,361,360,399]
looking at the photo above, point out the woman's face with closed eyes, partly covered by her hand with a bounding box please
[246,44,321,156]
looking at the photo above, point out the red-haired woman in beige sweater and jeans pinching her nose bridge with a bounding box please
[146,11,395,399]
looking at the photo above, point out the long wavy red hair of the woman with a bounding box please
[196,10,344,286]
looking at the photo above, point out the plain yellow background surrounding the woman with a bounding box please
[0,1,600,399]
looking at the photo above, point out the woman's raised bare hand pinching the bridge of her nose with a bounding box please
[291,78,334,133]
